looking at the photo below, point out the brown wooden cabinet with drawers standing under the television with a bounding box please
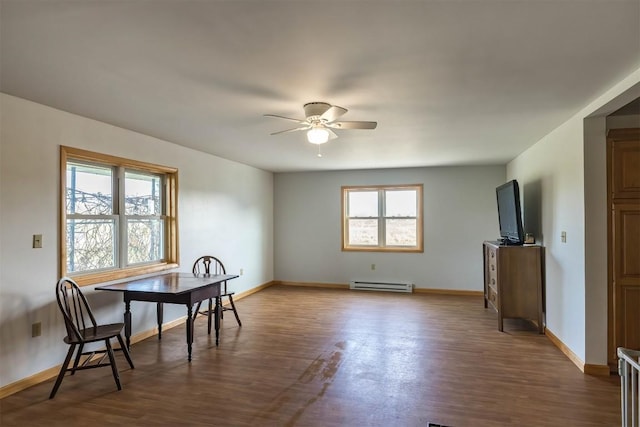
[483,241,544,333]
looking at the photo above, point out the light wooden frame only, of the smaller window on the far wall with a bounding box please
[341,184,424,253]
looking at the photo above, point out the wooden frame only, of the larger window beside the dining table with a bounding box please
[58,145,179,286]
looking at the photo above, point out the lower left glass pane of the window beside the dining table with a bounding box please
[67,219,116,273]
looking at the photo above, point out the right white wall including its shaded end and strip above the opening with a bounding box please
[507,70,640,365]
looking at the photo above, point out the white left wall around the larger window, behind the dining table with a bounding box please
[0,94,273,386]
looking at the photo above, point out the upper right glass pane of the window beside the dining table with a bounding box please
[124,172,162,215]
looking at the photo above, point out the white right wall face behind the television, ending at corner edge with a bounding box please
[507,120,585,360]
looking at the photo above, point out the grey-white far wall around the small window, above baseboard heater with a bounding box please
[274,166,505,291]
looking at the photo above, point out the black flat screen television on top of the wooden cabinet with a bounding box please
[496,179,524,245]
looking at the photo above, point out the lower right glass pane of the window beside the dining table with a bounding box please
[127,219,164,264]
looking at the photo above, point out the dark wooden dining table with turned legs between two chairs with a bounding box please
[95,273,238,362]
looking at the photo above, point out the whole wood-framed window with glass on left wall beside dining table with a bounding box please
[60,147,178,284]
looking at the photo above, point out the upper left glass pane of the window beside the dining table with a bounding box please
[66,162,113,215]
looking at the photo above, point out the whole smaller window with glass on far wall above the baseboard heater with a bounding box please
[342,184,423,252]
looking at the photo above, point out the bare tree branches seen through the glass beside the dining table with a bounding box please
[66,161,164,273]
